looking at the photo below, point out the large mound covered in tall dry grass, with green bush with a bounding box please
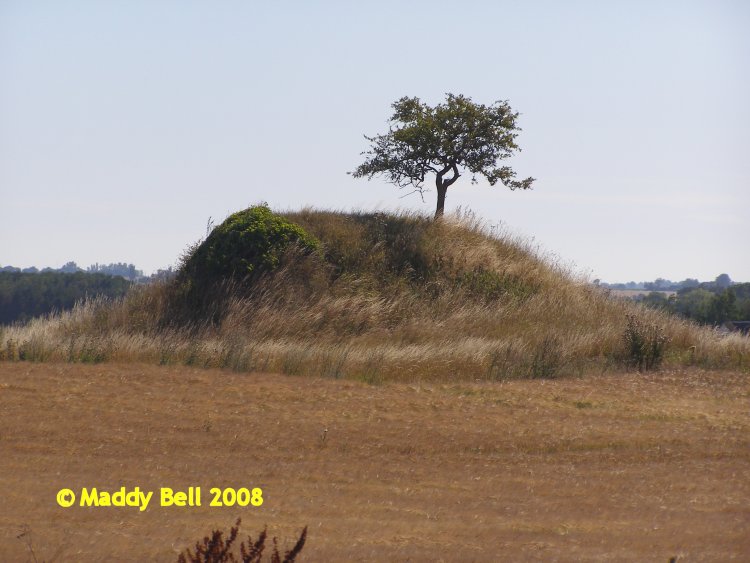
[0,208,750,383]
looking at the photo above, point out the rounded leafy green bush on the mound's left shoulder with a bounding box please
[183,205,320,285]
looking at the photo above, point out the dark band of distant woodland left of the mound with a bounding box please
[0,271,132,324]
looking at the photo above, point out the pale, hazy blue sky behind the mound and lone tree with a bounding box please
[0,0,750,281]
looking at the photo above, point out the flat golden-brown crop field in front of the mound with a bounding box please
[0,363,750,562]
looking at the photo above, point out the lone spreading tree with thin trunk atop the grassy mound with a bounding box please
[352,94,534,218]
